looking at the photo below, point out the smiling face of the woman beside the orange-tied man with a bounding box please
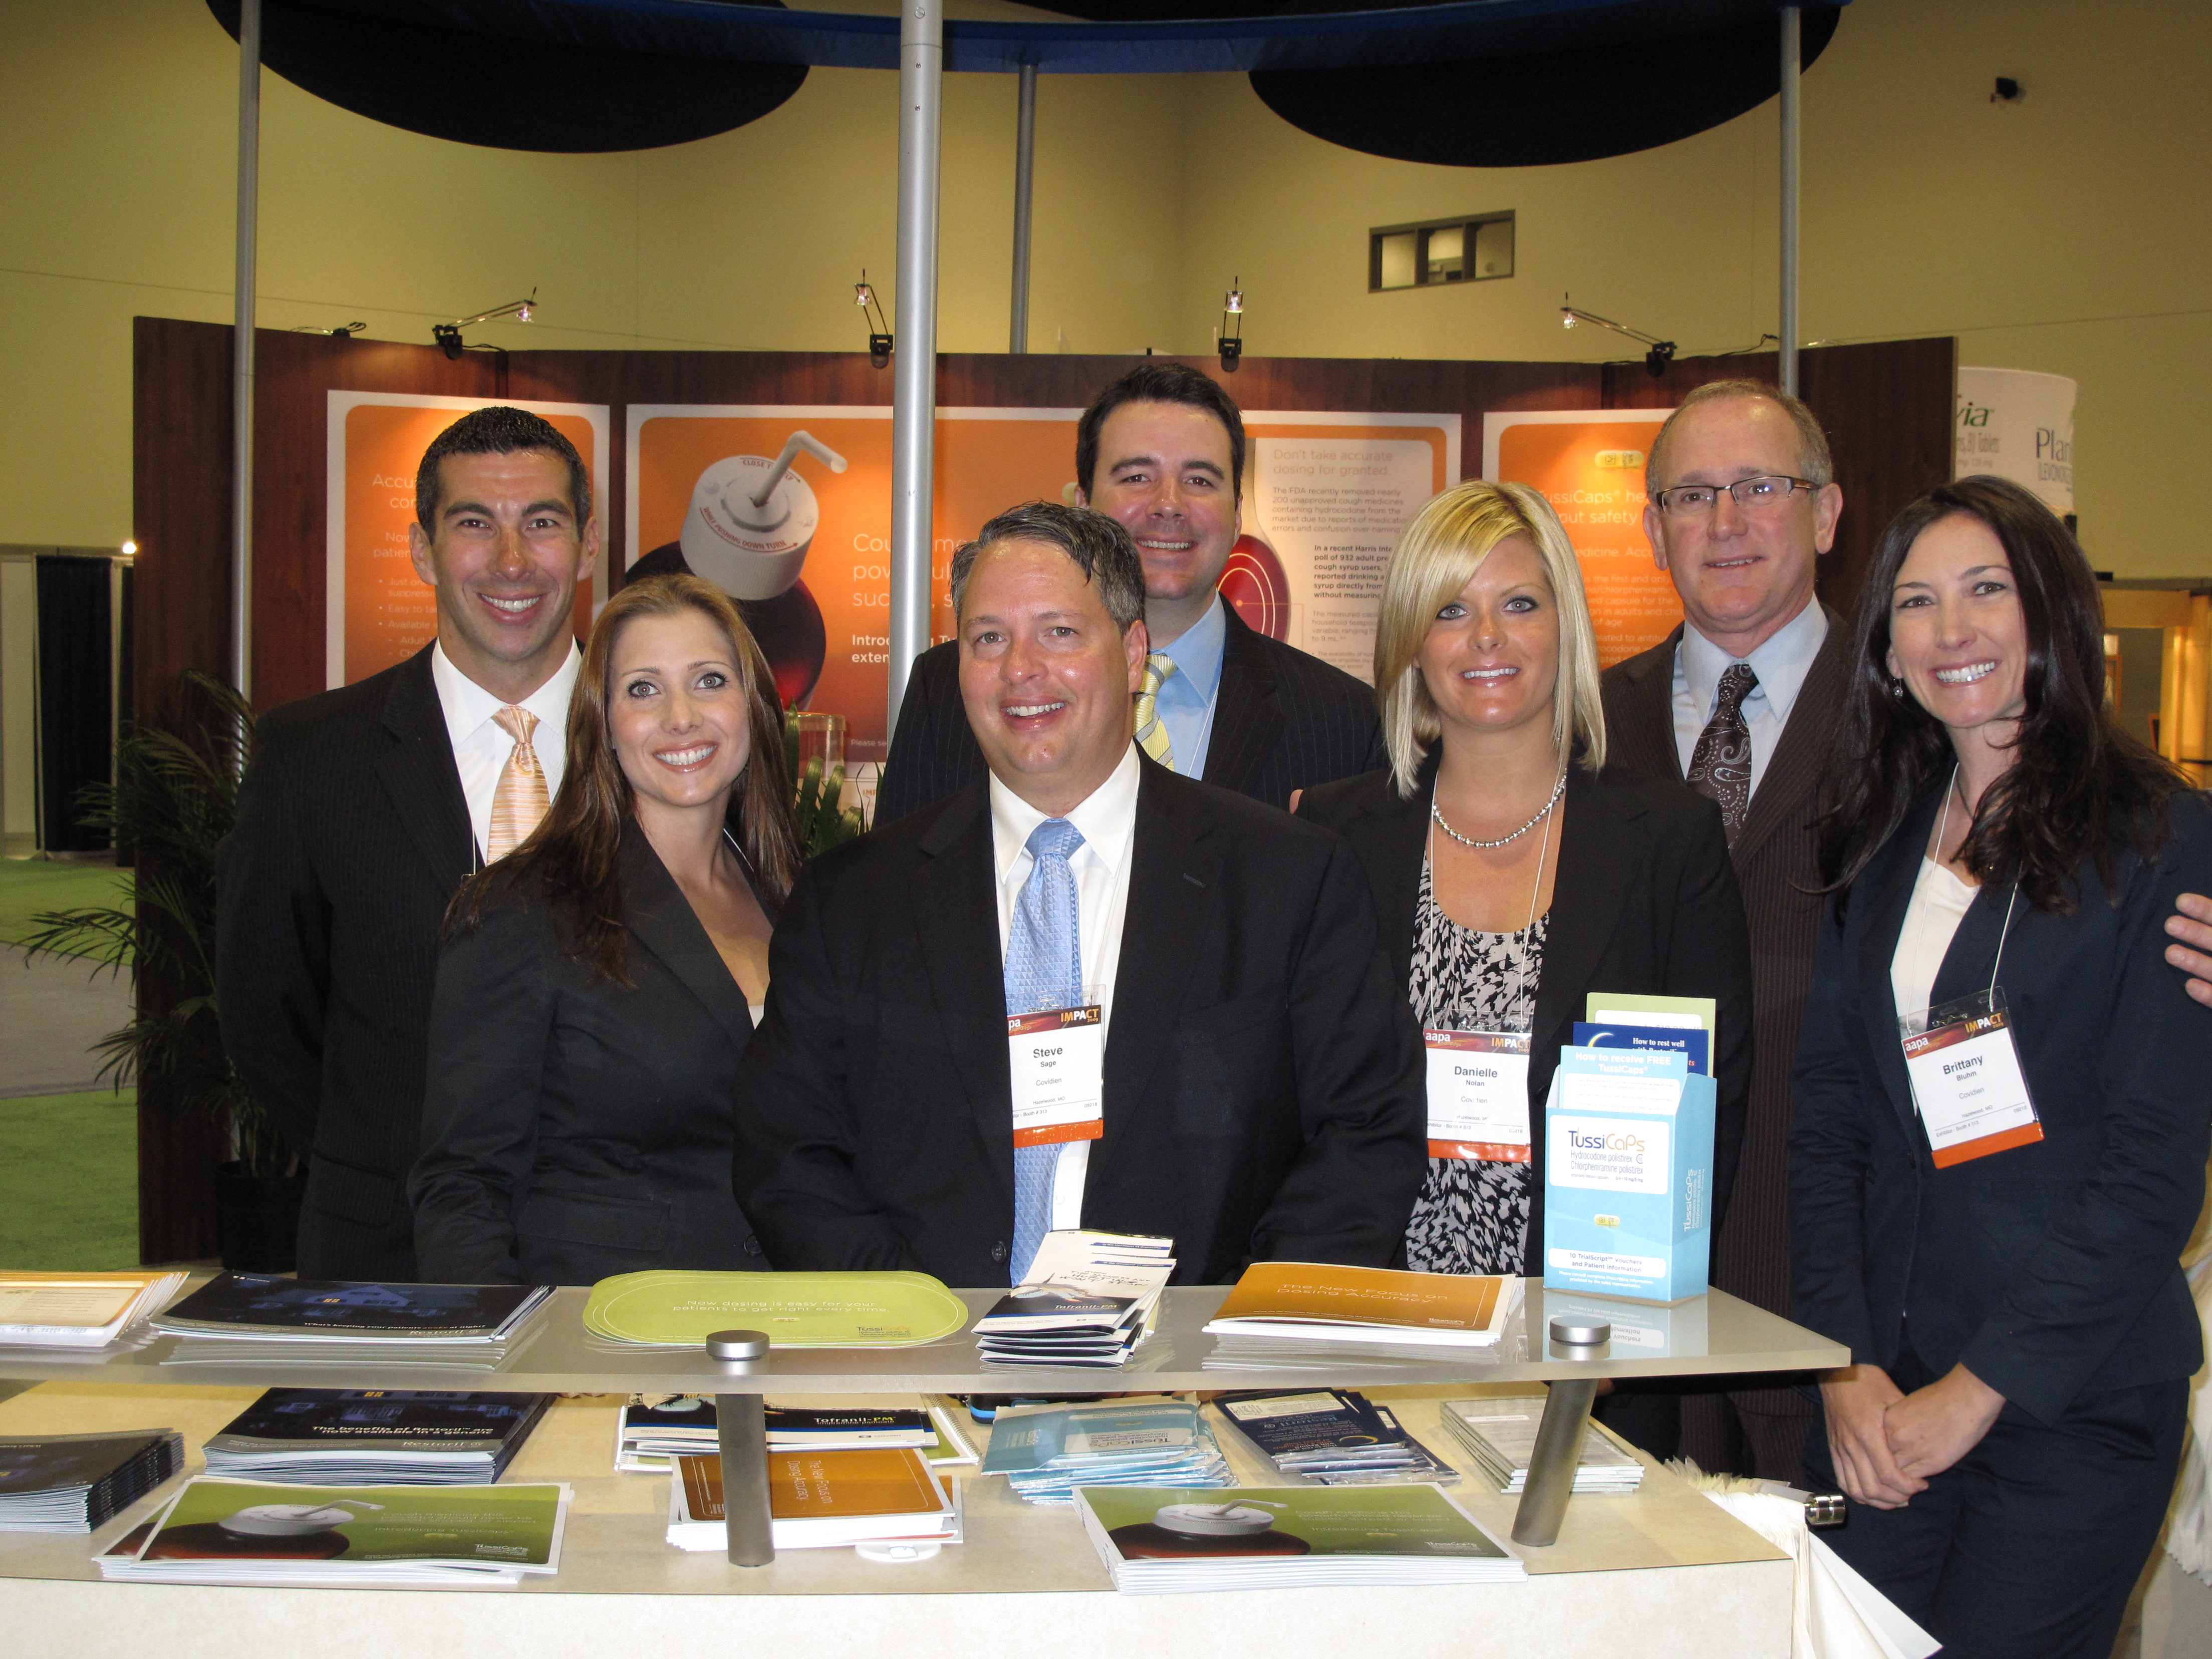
[606,611,752,816]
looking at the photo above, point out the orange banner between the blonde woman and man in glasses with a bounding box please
[1482,409,1681,668]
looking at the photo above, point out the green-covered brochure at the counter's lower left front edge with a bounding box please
[139,1475,569,1573]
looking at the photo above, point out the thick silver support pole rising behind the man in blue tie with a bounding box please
[885,0,945,732]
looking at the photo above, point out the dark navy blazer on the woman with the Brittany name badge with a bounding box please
[1790,787,2212,1422]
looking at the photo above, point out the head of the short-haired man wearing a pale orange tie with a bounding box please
[407,449,600,703]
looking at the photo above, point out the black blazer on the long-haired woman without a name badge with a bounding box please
[407,818,767,1285]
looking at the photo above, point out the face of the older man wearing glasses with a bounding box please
[1643,398,1843,657]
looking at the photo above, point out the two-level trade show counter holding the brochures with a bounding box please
[0,1287,1843,1659]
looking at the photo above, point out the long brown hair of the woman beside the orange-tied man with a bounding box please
[449,575,798,984]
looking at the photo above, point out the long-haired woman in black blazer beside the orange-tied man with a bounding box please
[407,575,798,1285]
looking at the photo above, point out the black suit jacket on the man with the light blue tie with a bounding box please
[734,761,1425,1285]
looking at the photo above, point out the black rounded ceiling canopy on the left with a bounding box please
[208,0,807,153]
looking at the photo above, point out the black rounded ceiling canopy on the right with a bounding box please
[1256,0,1838,168]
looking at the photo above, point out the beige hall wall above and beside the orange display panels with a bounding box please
[0,0,2212,575]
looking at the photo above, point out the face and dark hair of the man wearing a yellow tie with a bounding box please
[1084,403,1237,639]
